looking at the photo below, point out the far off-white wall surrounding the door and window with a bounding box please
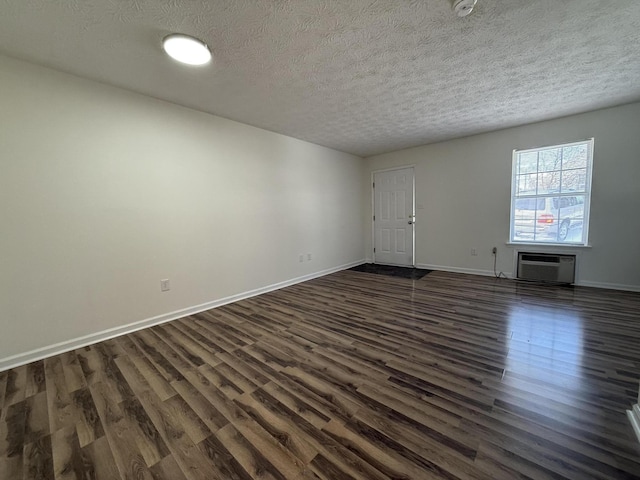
[365,103,640,290]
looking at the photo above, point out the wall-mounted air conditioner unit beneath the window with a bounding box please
[517,252,576,283]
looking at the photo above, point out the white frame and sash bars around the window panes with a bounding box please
[508,138,594,247]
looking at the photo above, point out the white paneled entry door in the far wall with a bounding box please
[373,167,415,266]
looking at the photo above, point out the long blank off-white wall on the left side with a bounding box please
[0,53,365,369]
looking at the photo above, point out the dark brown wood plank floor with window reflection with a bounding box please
[0,271,640,480]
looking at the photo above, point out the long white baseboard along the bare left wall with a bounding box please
[0,259,365,372]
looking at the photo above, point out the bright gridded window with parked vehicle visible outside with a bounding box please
[510,139,593,245]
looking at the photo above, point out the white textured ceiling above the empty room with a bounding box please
[0,0,640,156]
